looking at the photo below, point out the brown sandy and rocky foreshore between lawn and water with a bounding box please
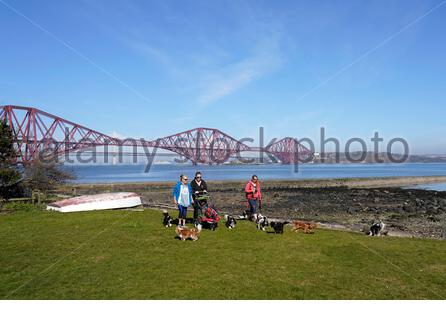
[63,173,446,239]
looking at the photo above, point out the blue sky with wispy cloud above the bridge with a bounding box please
[0,0,446,153]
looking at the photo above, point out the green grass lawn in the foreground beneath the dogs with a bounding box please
[0,206,446,299]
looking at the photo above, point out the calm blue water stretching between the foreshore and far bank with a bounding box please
[62,163,446,190]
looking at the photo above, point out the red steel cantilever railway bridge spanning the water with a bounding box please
[0,105,312,164]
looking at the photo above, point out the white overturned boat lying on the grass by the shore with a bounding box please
[46,192,141,212]
